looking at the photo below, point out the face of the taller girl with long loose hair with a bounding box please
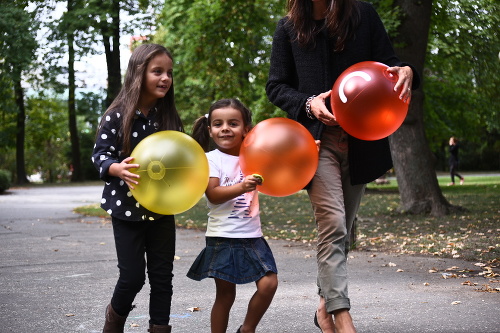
[139,53,173,107]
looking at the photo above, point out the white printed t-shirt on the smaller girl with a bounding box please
[206,149,262,238]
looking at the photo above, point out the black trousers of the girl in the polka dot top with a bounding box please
[111,216,175,325]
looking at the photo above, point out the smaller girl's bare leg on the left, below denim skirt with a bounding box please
[210,279,236,333]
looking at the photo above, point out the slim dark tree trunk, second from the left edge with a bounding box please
[67,0,83,182]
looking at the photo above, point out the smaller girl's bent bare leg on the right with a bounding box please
[240,273,278,333]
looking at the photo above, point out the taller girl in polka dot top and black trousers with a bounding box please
[92,44,183,333]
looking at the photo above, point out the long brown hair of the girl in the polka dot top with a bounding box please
[98,44,184,156]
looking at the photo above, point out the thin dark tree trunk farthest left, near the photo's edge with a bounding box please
[14,76,29,185]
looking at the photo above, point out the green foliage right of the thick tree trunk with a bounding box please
[424,0,500,169]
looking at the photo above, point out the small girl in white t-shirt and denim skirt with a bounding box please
[187,99,278,333]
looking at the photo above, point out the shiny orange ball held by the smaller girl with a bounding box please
[240,118,318,197]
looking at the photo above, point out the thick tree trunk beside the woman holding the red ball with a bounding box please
[389,0,458,216]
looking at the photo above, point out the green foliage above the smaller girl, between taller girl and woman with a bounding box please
[154,0,284,128]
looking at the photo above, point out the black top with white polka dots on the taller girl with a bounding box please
[92,109,163,221]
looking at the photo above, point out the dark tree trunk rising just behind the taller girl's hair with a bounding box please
[101,0,122,107]
